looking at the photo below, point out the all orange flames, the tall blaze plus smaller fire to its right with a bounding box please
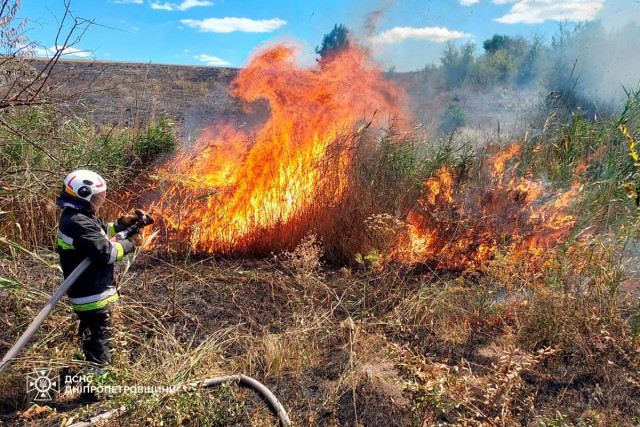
[153,46,579,269]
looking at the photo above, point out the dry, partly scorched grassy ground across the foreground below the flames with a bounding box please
[0,242,640,426]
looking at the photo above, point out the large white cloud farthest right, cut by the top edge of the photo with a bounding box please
[494,0,605,24]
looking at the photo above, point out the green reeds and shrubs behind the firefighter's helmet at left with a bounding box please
[0,106,177,248]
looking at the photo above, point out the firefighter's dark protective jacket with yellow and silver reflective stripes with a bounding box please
[58,207,135,311]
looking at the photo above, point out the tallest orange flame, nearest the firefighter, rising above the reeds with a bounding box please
[154,46,407,252]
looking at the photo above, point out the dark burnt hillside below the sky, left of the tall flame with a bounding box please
[32,58,243,141]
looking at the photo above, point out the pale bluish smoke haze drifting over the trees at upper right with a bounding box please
[382,20,640,141]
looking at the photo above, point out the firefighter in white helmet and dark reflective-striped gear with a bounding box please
[58,170,146,399]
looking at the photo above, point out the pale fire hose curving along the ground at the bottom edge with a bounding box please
[68,375,291,427]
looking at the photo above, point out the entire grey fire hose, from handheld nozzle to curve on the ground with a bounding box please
[0,215,291,427]
